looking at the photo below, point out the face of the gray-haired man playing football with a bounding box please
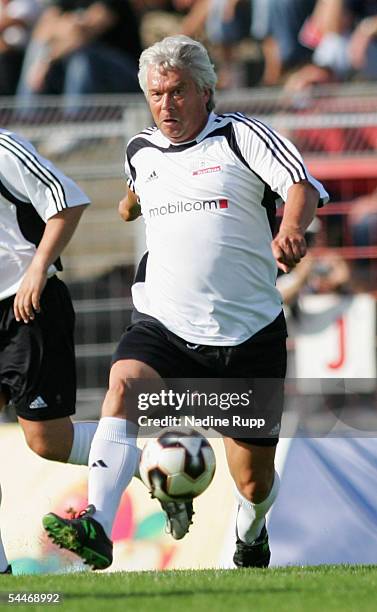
[147,66,210,142]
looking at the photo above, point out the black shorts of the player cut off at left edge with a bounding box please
[0,276,76,421]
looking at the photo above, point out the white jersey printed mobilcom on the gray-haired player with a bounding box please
[125,113,328,346]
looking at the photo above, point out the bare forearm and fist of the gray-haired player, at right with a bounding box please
[271,180,320,272]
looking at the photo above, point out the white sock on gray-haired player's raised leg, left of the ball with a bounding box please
[88,417,140,537]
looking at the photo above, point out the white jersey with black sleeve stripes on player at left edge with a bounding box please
[0,130,89,300]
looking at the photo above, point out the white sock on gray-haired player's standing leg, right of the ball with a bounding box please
[236,472,280,544]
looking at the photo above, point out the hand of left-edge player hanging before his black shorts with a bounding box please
[13,261,47,323]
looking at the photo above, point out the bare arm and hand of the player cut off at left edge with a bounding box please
[13,205,86,323]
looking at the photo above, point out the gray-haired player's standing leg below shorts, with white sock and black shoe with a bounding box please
[224,438,279,567]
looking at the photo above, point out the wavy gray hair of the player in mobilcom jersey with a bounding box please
[138,34,217,112]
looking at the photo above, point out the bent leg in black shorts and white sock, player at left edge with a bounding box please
[12,277,96,465]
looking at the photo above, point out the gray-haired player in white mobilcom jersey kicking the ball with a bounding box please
[44,36,328,569]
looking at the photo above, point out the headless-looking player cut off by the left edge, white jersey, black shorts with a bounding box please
[0,130,97,465]
